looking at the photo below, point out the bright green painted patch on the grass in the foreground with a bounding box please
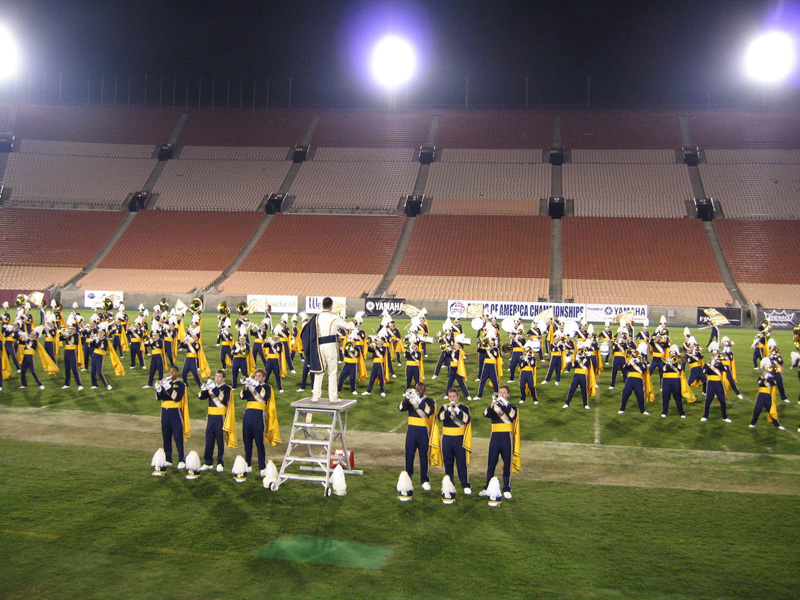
[253,535,392,569]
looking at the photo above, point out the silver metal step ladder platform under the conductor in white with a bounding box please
[272,398,364,497]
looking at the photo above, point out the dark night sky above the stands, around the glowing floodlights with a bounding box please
[0,0,800,106]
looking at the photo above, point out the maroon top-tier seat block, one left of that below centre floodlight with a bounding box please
[178,108,313,148]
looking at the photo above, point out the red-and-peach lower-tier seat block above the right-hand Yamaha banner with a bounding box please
[562,217,732,306]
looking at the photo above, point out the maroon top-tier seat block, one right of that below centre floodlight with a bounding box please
[436,110,553,149]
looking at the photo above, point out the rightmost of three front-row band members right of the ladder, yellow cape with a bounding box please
[479,385,522,500]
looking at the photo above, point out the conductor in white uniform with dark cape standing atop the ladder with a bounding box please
[301,296,353,402]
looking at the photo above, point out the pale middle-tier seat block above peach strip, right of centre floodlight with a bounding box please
[425,163,552,200]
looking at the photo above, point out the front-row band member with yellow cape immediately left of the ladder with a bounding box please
[240,369,281,477]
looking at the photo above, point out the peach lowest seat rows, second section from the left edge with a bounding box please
[75,267,219,294]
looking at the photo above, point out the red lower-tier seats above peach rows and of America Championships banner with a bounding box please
[395,215,550,280]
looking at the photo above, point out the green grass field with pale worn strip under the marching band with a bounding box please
[0,315,800,599]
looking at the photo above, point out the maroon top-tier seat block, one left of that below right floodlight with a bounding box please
[560,110,681,150]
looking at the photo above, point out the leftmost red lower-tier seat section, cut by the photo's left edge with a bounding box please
[0,208,125,264]
